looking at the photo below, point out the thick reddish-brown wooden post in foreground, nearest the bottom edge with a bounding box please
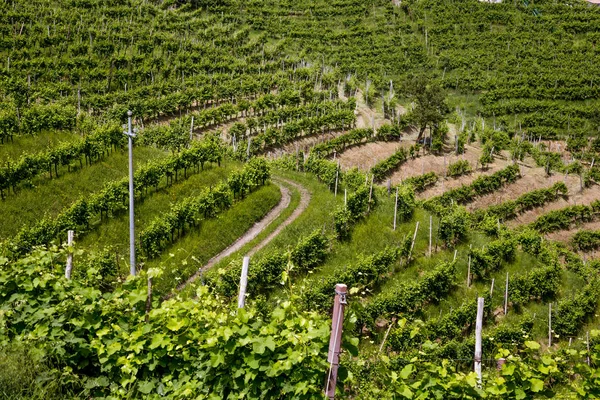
[325,283,348,399]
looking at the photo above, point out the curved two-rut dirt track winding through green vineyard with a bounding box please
[177,178,311,290]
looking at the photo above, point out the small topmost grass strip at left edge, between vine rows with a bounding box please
[0,131,81,161]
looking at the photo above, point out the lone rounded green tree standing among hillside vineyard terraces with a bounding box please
[404,75,450,142]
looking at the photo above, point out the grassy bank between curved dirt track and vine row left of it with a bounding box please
[145,183,281,293]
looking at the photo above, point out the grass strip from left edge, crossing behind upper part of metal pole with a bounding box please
[0,147,166,240]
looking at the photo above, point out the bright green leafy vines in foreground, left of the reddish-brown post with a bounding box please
[0,251,340,398]
